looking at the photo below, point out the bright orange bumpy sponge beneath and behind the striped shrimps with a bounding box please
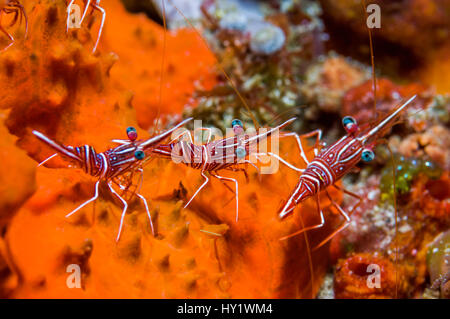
[0,0,334,298]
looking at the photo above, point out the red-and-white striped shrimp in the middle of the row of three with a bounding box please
[151,118,301,221]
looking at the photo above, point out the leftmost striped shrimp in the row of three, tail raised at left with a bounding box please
[33,118,192,241]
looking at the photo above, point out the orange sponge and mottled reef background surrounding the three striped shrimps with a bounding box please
[0,0,450,298]
